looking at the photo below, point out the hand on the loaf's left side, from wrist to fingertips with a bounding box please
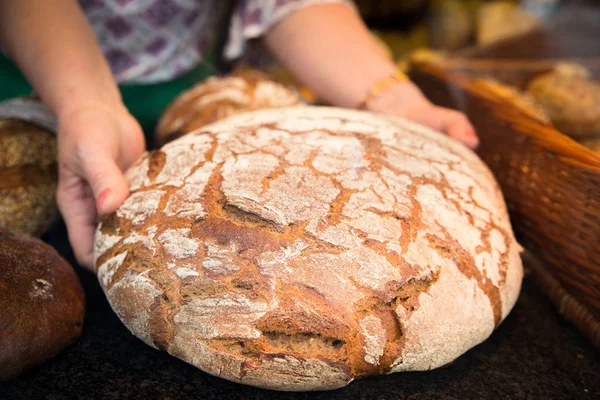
[57,104,145,268]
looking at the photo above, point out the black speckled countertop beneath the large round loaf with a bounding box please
[0,226,600,400]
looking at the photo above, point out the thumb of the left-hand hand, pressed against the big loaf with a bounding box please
[82,149,129,215]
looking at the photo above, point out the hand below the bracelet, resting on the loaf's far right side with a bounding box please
[367,81,479,149]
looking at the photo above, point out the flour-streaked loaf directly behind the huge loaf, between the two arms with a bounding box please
[156,69,301,147]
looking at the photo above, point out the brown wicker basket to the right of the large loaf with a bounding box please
[410,63,600,349]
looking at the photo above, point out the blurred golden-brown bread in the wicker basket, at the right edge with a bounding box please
[528,65,600,139]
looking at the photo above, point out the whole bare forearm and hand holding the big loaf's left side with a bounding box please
[0,0,144,268]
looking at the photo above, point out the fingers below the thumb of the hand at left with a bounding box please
[56,168,96,271]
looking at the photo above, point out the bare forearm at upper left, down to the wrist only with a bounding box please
[0,0,120,118]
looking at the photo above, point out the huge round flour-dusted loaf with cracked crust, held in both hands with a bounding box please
[94,106,522,390]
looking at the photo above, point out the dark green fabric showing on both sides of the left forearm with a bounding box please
[0,51,216,147]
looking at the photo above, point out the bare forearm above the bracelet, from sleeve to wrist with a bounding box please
[266,4,412,107]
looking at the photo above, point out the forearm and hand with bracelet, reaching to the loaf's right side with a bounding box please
[266,4,478,147]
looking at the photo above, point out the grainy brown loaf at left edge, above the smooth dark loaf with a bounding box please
[0,119,58,235]
